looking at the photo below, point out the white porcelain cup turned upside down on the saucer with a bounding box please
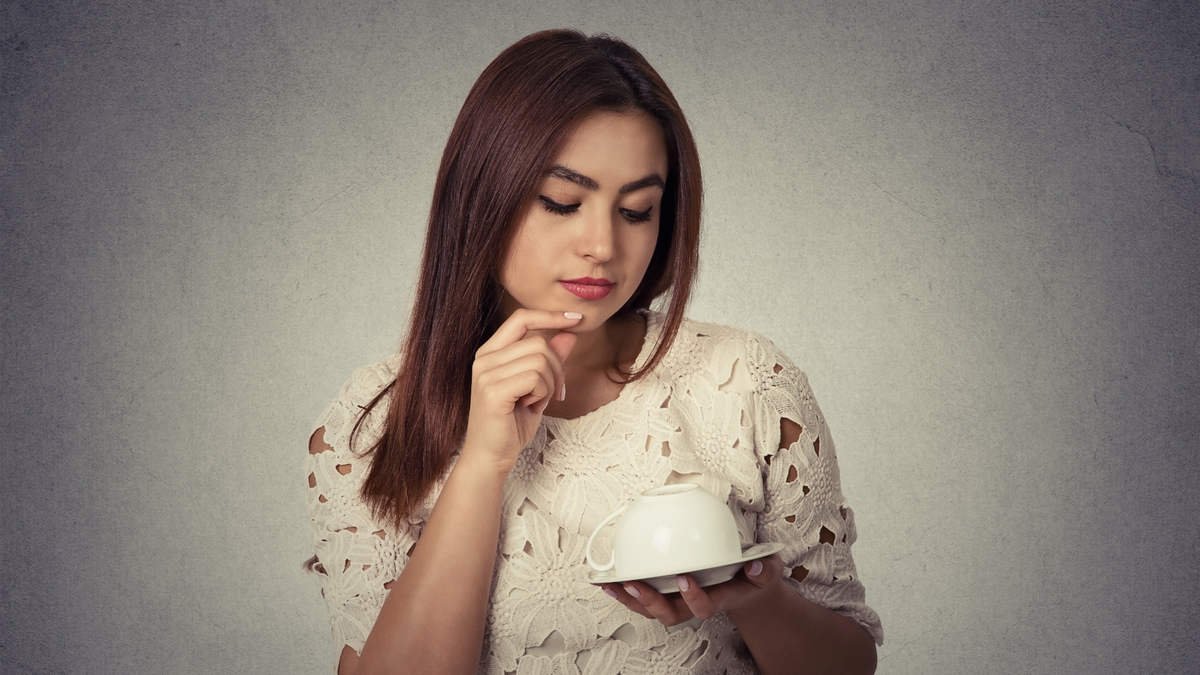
[587,483,742,579]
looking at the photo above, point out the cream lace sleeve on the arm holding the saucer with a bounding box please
[751,336,883,645]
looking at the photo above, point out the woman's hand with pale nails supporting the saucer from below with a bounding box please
[602,554,786,626]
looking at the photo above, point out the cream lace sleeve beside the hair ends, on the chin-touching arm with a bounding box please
[304,357,416,663]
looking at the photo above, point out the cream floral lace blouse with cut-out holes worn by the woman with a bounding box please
[304,313,883,675]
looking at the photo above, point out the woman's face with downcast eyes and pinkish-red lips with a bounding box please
[500,112,667,333]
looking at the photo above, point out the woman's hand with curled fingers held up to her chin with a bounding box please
[462,309,583,473]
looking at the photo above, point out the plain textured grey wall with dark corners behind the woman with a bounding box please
[0,0,1200,674]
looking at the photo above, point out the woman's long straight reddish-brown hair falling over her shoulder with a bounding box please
[352,30,701,524]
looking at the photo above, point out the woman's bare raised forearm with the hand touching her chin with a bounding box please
[338,310,578,675]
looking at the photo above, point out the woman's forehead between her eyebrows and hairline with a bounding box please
[552,110,667,182]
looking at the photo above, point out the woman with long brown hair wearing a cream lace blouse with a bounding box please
[306,31,882,675]
